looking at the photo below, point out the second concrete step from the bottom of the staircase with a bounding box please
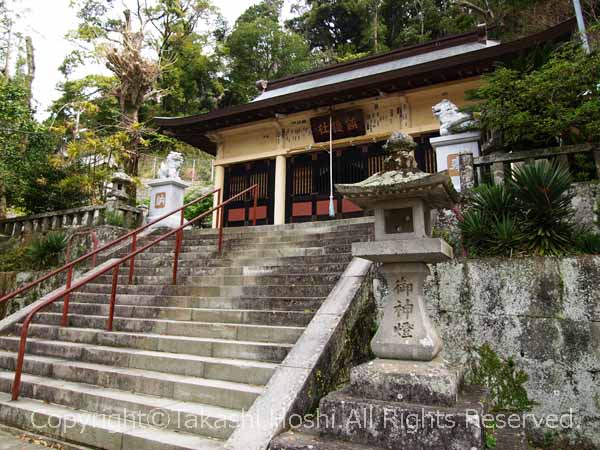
[0,371,241,439]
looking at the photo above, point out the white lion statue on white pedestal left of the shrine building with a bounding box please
[146,152,189,228]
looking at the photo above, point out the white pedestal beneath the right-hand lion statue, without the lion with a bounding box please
[429,131,481,192]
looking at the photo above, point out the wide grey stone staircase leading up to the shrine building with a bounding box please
[0,219,372,450]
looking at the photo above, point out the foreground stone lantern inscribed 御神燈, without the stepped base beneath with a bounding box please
[336,133,458,361]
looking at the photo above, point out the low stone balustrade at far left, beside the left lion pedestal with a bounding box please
[0,205,142,237]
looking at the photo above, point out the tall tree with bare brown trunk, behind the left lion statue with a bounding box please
[63,0,219,177]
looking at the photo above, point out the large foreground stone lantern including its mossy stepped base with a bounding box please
[310,133,484,450]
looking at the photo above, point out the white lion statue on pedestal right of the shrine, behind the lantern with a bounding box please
[429,100,481,191]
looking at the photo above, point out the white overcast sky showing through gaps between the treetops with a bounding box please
[18,0,259,118]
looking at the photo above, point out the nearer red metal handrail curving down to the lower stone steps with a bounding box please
[12,184,259,401]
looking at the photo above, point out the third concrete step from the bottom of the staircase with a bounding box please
[0,351,264,410]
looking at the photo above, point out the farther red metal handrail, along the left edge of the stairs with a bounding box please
[0,189,221,326]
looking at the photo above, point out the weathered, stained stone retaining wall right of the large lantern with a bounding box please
[396,256,600,448]
